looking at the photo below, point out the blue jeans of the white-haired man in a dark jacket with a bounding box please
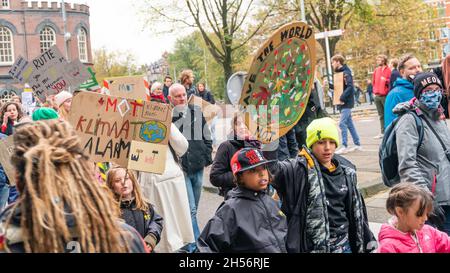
[184,169,203,249]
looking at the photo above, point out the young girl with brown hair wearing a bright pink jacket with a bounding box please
[378,183,450,253]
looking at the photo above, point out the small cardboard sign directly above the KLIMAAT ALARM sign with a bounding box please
[108,76,146,100]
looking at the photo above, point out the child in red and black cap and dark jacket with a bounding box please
[197,148,287,253]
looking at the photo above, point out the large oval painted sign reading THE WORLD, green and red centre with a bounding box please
[239,22,316,143]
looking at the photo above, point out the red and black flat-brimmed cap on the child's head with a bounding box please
[230,148,273,175]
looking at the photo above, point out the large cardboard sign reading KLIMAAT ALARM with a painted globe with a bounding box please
[69,92,172,173]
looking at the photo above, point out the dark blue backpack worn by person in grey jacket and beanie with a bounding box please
[378,111,424,187]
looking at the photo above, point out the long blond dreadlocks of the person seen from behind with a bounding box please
[7,120,129,252]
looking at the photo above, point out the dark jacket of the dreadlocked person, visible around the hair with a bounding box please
[0,205,148,253]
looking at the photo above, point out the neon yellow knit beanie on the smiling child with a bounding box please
[306,118,339,148]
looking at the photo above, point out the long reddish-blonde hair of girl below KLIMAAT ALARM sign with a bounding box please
[106,166,149,212]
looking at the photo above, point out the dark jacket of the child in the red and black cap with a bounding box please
[197,187,287,253]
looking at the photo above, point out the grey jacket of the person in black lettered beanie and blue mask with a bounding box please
[394,99,450,206]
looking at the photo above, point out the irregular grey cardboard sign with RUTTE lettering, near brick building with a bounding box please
[9,45,89,102]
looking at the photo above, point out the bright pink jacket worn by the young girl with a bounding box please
[378,217,450,253]
